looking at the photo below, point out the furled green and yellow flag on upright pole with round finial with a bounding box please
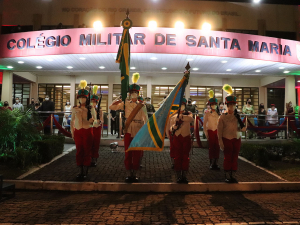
[116,18,132,101]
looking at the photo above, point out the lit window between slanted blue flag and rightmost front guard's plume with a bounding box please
[190,86,223,114]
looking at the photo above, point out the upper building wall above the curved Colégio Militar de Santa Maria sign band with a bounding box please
[0,0,299,32]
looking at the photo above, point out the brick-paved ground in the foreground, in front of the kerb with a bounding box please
[0,191,300,225]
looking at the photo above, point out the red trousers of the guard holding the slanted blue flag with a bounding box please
[172,134,191,171]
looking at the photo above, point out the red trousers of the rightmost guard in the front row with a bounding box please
[222,138,241,171]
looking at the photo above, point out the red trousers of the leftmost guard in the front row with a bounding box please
[74,128,93,166]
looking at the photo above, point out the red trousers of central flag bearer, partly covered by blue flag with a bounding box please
[124,133,143,170]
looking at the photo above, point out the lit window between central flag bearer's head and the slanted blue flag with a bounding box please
[151,85,175,111]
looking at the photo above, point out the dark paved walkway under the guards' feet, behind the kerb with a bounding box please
[23,146,281,183]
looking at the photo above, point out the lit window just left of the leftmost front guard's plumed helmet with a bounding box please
[38,84,71,111]
